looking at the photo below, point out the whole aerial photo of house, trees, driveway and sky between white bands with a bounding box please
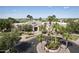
[0,6,79,53]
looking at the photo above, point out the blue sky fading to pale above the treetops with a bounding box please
[0,6,79,18]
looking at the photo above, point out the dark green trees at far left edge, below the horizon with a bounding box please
[0,17,17,32]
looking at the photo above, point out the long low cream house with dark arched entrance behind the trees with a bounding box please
[13,21,67,31]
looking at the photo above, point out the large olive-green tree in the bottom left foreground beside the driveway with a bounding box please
[0,32,20,52]
